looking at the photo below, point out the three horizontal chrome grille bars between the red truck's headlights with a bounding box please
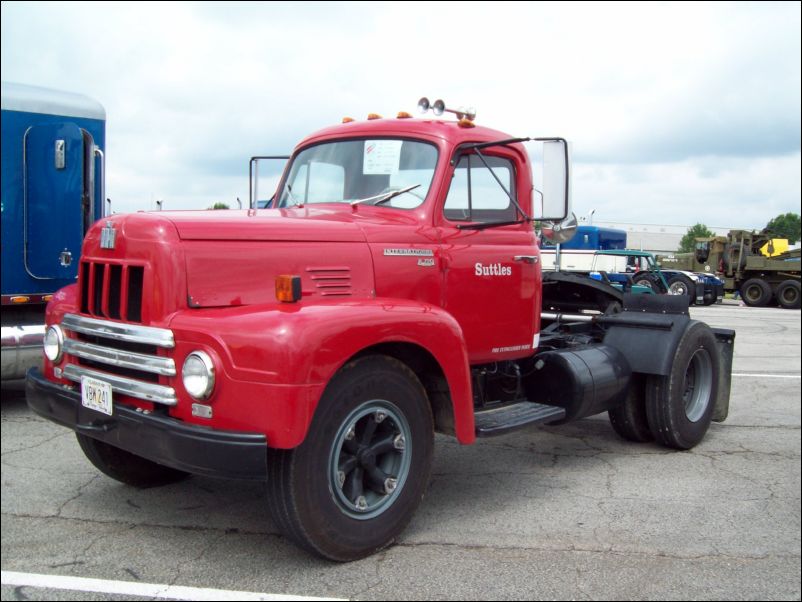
[61,314,177,406]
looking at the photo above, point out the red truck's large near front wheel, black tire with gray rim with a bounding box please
[267,356,434,562]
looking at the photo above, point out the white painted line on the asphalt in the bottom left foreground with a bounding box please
[1,571,343,600]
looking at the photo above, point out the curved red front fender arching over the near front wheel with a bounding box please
[170,298,475,443]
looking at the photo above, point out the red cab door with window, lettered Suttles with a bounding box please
[440,155,540,363]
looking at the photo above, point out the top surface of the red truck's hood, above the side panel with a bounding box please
[164,208,365,242]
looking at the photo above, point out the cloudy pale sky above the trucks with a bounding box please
[0,2,802,228]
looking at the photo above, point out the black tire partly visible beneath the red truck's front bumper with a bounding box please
[75,433,189,489]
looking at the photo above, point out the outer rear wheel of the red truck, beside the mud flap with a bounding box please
[646,321,719,449]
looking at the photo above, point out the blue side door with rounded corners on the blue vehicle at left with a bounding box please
[24,123,94,280]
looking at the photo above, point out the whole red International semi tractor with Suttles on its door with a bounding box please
[27,101,735,561]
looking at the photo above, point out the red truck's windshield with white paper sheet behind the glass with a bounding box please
[278,138,437,209]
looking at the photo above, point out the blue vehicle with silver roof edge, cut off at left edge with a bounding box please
[0,82,106,381]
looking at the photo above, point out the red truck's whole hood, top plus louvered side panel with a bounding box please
[160,207,375,307]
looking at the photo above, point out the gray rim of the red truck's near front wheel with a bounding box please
[328,399,412,520]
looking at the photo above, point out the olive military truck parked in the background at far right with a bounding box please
[660,229,800,309]
